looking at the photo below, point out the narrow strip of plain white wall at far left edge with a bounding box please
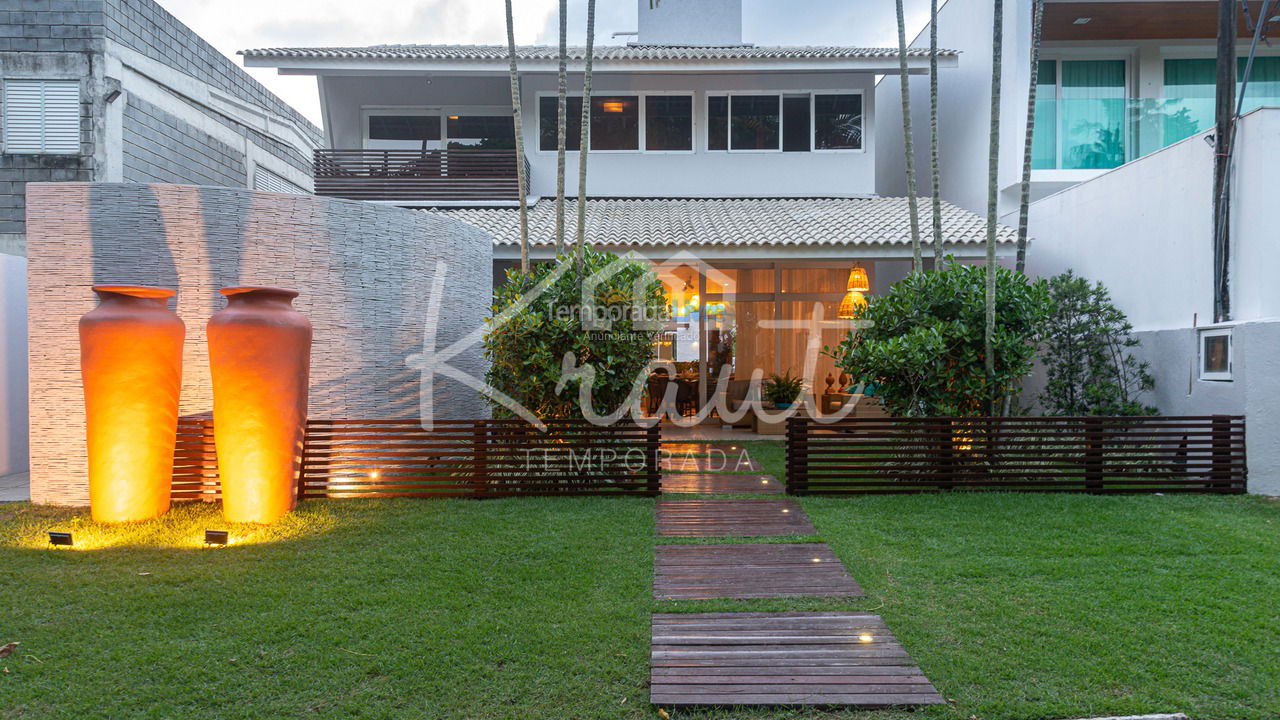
[0,252,28,477]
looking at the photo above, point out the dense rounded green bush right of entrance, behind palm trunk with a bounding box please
[828,259,1048,416]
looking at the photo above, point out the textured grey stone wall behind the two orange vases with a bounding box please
[27,183,493,505]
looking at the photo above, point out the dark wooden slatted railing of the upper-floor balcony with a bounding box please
[315,147,529,202]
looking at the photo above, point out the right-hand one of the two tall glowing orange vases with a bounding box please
[209,287,311,524]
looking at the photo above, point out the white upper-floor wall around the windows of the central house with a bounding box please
[321,72,877,197]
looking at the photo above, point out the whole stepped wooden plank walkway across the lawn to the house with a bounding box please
[649,443,943,708]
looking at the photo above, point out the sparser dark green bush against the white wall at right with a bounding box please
[1039,270,1157,415]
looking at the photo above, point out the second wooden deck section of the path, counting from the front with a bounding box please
[653,543,865,600]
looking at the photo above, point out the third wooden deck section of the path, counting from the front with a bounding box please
[658,498,814,538]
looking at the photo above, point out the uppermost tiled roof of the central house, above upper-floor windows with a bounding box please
[239,45,957,61]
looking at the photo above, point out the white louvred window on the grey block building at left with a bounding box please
[0,79,81,154]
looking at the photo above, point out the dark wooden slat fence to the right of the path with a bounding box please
[787,415,1248,495]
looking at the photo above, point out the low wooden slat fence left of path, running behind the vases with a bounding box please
[174,419,662,500]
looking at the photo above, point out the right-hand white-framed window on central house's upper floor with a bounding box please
[707,92,863,152]
